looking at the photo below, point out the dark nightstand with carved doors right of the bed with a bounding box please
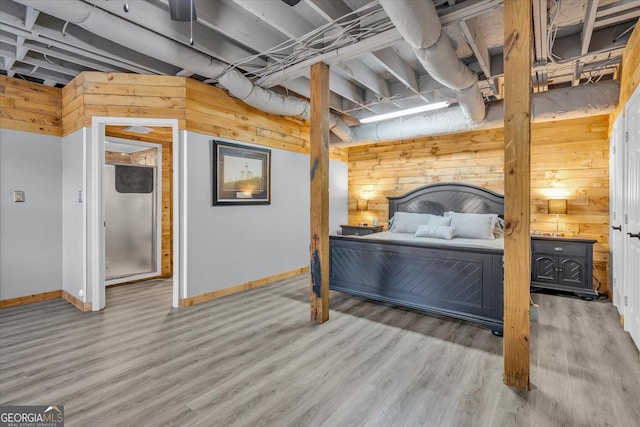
[531,236,598,300]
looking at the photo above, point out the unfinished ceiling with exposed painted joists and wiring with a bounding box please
[0,0,640,140]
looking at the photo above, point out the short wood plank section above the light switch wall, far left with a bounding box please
[0,75,62,136]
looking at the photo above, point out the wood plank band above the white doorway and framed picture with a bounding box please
[62,72,347,162]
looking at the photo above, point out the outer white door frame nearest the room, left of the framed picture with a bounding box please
[87,117,181,311]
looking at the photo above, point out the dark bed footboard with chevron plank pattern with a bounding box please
[329,236,503,334]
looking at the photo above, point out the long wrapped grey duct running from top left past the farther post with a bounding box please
[15,0,353,141]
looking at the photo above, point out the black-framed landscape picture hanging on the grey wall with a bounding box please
[212,140,271,205]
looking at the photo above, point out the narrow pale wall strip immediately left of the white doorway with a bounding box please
[62,128,87,301]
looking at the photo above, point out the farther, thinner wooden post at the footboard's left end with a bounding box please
[309,62,329,323]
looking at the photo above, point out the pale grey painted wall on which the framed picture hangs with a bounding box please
[181,132,347,297]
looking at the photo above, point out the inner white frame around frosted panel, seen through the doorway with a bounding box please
[103,137,162,286]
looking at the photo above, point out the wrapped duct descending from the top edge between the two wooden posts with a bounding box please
[379,0,485,123]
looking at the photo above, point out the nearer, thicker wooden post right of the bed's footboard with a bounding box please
[503,0,532,390]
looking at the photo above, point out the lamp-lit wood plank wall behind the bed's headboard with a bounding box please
[349,115,609,292]
